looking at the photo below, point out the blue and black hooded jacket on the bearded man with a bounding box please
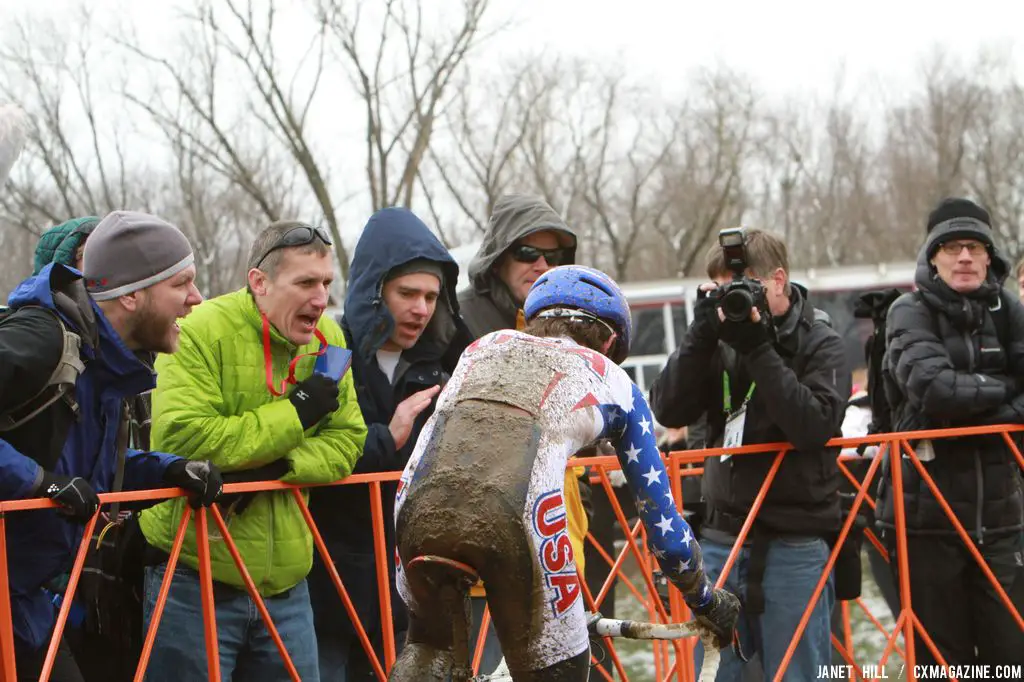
[0,264,180,648]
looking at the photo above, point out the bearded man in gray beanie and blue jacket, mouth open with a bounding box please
[0,211,221,680]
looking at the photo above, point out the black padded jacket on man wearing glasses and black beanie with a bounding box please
[878,245,1024,541]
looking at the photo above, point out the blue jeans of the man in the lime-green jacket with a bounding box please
[142,563,319,682]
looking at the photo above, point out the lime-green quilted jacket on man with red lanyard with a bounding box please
[140,289,367,596]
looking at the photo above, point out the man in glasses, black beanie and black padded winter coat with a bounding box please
[878,199,1024,665]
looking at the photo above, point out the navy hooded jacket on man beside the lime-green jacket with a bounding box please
[310,208,471,632]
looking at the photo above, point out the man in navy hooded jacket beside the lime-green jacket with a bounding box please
[309,208,471,682]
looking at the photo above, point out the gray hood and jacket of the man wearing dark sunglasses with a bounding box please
[459,195,577,338]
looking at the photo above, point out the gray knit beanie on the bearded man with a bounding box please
[82,211,195,301]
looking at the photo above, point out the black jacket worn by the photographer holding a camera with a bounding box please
[650,286,851,536]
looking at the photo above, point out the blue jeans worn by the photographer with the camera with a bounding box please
[694,538,836,682]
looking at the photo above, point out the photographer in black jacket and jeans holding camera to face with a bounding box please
[650,228,851,682]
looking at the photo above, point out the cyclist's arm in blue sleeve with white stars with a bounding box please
[602,384,712,608]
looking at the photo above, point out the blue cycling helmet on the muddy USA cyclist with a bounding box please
[523,265,633,365]
